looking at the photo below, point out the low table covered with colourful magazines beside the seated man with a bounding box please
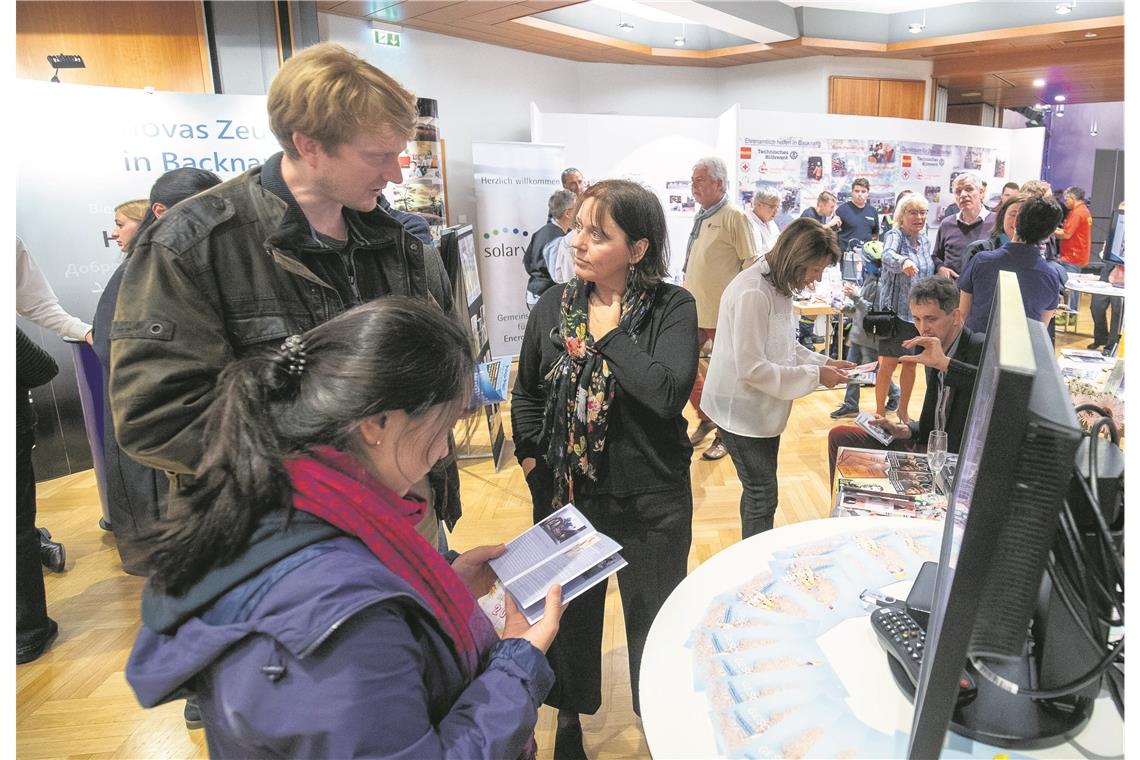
[831,446,958,520]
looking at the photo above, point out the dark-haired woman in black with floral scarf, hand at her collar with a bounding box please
[511,180,697,758]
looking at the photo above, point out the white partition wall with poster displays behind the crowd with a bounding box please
[531,106,1044,273]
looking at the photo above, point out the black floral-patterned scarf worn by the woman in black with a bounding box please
[543,277,653,508]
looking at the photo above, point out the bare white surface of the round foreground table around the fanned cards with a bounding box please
[641,517,1124,760]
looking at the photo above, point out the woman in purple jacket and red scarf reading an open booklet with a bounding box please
[127,296,561,758]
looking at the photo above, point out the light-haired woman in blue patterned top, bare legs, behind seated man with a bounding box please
[874,193,935,423]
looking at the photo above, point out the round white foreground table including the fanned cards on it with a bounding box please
[641,517,1123,758]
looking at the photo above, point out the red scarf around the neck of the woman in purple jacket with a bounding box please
[286,446,498,681]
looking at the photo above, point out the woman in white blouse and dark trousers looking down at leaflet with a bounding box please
[701,219,853,538]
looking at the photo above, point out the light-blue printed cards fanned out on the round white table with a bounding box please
[689,529,941,758]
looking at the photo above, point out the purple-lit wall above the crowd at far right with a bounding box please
[1042,103,1124,190]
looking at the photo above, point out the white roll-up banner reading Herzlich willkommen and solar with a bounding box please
[471,142,563,357]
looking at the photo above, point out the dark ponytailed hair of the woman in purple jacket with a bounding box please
[140,296,473,594]
